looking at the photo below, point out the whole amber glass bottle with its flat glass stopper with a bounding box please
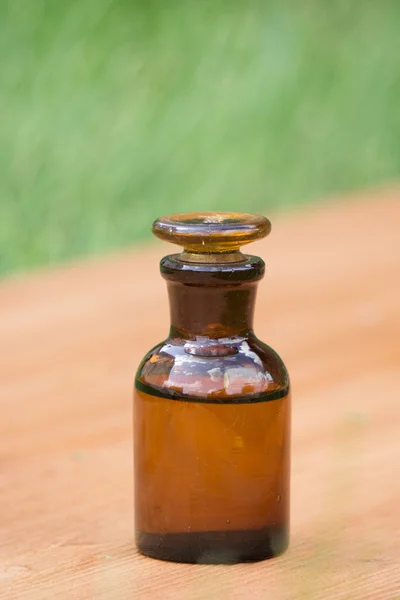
[134,213,290,563]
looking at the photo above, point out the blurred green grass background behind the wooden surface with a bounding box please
[0,0,400,273]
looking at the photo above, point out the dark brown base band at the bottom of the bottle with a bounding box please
[136,527,289,564]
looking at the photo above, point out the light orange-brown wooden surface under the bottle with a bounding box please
[0,192,400,600]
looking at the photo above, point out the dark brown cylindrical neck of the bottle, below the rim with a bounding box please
[168,281,257,339]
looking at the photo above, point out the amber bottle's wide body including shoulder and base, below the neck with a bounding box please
[134,334,290,563]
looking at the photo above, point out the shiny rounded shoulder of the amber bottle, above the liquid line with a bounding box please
[136,335,289,398]
